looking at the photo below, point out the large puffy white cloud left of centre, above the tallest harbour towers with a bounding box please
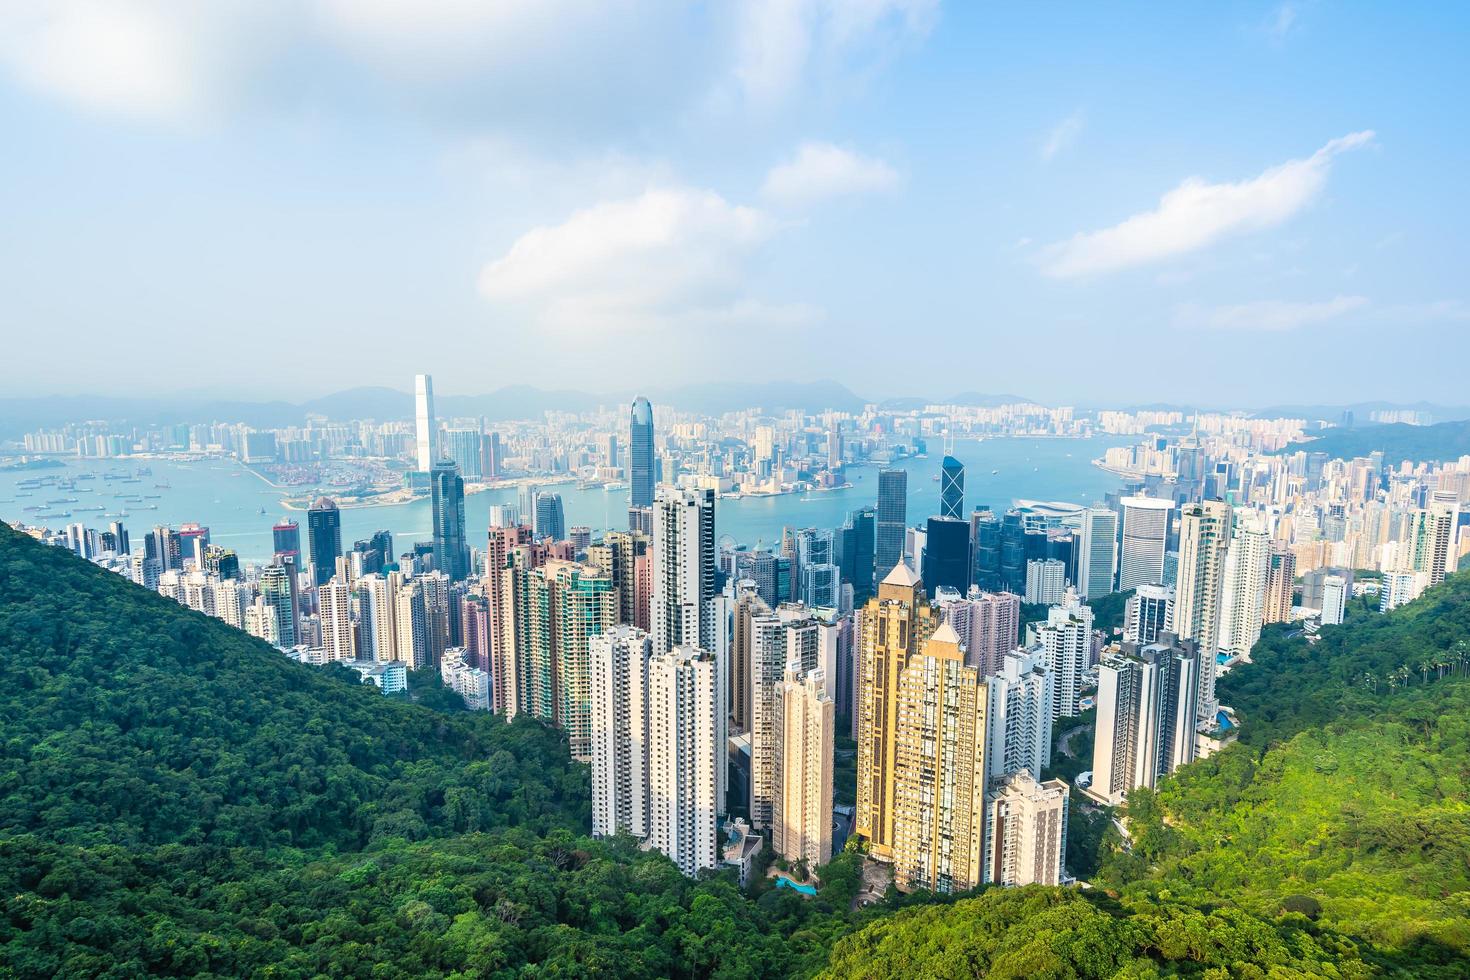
[479,187,809,335]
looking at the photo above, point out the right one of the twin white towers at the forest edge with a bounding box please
[647,646,726,877]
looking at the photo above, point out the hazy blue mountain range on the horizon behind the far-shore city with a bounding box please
[0,381,1029,438]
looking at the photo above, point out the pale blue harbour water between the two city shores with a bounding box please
[0,436,1136,561]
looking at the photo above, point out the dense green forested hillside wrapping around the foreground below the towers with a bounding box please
[0,525,1470,979]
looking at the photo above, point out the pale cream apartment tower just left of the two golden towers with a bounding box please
[770,664,835,870]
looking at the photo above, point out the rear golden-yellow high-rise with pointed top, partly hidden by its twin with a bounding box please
[854,561,953,861]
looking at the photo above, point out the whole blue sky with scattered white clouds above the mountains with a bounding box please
[0,0,1470,407]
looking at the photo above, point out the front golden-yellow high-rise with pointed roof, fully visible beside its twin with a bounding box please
[892,623,986,892]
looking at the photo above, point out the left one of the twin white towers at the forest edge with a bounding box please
[591,626,653,837]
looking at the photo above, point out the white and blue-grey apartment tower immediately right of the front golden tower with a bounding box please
[985,649,1057,785]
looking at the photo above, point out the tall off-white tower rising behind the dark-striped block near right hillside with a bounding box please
[1170,500,1230,724]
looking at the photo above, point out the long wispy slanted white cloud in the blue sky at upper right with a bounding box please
[1042,131,1373,279]
